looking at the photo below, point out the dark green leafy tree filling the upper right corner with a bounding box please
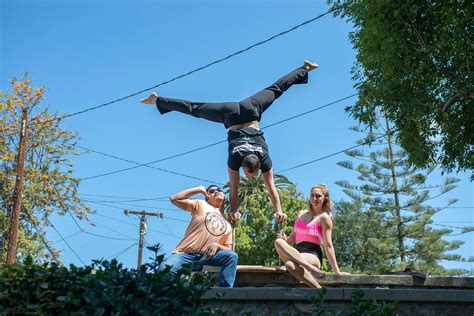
[329,0,474,174]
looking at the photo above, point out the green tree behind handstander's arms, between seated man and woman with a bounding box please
[226,173,307,265]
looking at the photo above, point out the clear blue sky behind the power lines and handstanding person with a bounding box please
[0,0,474,269]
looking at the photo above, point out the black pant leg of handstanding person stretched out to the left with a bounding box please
[156,96,240,123]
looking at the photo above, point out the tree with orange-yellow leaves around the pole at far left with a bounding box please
[0,77,89,260]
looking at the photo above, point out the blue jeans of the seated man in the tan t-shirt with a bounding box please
[160,250,238,287]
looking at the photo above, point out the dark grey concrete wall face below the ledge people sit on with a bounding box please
[203,287,474,316]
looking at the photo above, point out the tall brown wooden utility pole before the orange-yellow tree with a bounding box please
[7,108,28,264]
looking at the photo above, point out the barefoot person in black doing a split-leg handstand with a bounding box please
[140,60,318,222]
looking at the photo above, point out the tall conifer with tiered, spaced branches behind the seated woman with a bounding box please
[335,119,471,273]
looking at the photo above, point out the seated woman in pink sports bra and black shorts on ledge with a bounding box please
[275,184,348,288]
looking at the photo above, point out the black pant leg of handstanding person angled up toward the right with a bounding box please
[240,67,308,116]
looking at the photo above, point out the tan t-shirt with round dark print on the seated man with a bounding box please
[173,200,232,253]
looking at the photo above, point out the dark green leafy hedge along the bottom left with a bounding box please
[0,247,218,315]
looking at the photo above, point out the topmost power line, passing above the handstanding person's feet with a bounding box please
[56,7,336,119]
